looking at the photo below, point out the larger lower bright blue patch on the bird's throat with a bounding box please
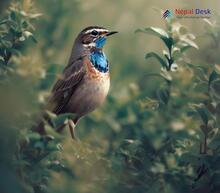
[90,51,109,73]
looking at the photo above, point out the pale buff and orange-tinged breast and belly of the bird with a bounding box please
[66,61,110,115]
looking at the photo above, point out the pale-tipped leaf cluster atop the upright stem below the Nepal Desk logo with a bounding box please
[136,18,198,71]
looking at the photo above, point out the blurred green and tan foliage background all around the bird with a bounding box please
[0,0,220,193]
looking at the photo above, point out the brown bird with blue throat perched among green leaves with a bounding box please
[34,26,118,139]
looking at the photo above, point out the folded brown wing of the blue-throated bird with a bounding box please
[46,58,86,114]
